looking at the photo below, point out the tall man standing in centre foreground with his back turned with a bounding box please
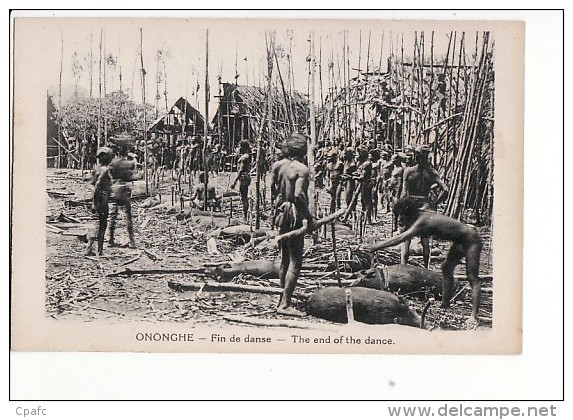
[274,133,316,316]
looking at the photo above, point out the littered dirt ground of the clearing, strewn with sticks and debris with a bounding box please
[46,169,493,329]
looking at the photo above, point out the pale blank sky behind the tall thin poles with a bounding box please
[26,18,482,119]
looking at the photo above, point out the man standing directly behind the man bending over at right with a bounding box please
[400,145,448,268]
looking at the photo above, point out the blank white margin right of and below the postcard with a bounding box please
[2,2,570,412]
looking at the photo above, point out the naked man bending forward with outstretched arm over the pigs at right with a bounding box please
[367,197,482,327]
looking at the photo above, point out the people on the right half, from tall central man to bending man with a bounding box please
[271,134,482,328]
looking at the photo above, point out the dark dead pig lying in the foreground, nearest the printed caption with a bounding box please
[307,287,421,327]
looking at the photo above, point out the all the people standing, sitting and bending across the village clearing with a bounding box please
[87,133,482,325]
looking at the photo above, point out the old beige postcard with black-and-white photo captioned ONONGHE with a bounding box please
[11,16,525,354]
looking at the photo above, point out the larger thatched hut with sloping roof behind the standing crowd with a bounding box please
[212,83,308,152]
